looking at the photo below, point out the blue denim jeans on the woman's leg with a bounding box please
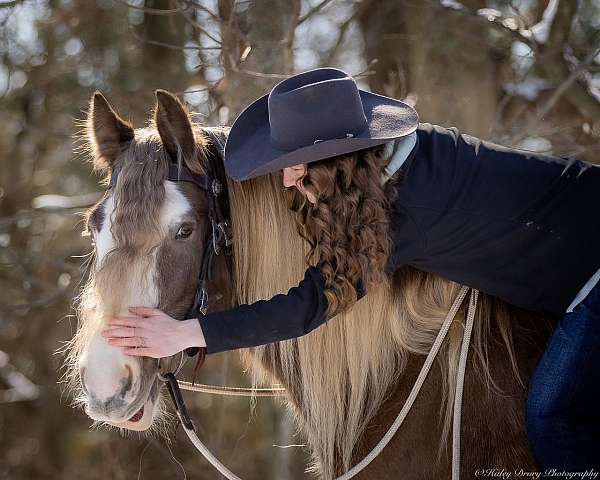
[527,284,600,472]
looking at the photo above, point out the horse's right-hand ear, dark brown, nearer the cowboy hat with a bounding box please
[154,90,202,171]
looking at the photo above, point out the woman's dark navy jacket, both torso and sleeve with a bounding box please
[199,124,600,353]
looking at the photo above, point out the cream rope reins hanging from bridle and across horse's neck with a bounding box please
[159,286,479,480]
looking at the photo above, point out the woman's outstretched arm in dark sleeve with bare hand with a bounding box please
[102,267,365,358]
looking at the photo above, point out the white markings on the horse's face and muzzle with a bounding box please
[80,181,191,428]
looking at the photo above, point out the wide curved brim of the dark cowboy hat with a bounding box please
[225,90,419,181]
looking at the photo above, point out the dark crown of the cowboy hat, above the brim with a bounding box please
[268,68,368,151]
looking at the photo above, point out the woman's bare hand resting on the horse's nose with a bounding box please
[102,307,206,358]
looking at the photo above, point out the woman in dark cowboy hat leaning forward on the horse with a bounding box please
[105,68,600,471]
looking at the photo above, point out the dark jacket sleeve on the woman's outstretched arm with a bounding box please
[198,266,365,353]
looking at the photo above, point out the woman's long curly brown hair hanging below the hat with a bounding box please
[286,146,399,317]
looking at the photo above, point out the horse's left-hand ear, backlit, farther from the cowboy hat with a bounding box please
[87,91,134,171]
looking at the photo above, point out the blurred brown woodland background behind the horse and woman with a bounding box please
[0,0,600,480]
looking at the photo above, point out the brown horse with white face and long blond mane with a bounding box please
[66,91,552,479]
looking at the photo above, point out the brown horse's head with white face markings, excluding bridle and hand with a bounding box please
[69,91,227,430]
